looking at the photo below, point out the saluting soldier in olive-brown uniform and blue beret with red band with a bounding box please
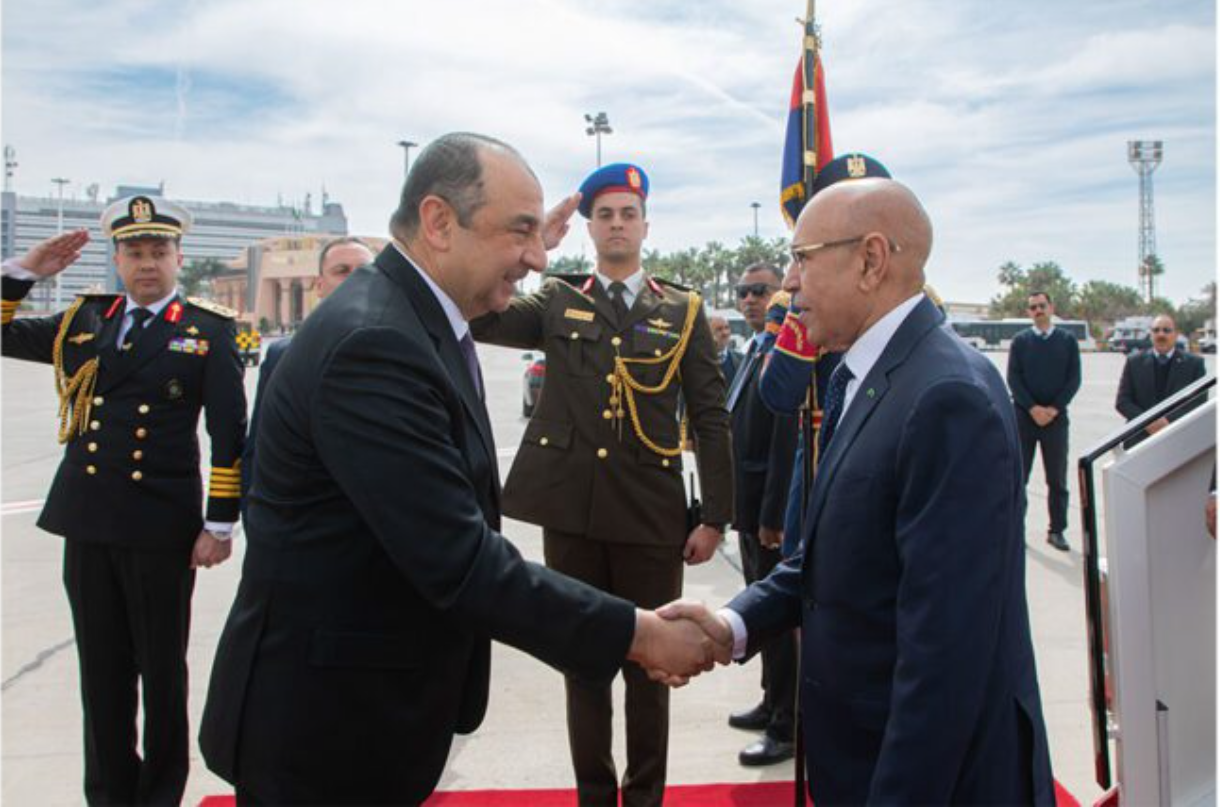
[471,164,733,806]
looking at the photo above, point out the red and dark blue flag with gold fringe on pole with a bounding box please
[780,52,834,227]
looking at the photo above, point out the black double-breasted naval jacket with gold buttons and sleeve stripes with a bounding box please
[2,278,245,549]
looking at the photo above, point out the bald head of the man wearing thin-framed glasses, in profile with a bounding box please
[793,178,932,350]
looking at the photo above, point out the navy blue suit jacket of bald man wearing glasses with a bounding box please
[730,299,1054,806]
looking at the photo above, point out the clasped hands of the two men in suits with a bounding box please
[627,601,733,687]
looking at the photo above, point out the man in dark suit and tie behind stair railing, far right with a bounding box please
[1114,314,1207,448]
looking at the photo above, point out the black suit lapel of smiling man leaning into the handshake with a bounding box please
[376,244,500,500]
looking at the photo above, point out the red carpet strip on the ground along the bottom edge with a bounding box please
[199,780,1080,808]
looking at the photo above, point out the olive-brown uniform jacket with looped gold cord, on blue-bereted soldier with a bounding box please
[471,275,733,547]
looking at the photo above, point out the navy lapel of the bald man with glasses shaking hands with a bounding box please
[802,298,943,558]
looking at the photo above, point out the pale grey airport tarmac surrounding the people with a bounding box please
[0,347,1214,806]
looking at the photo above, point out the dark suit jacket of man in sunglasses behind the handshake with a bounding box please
[730,339,799,535]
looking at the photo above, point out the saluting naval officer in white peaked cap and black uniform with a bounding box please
[2,197,245,806]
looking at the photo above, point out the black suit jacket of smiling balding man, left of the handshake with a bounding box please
[200,247,634,804]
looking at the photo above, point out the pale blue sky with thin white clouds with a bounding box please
[0,0,1216,303]
